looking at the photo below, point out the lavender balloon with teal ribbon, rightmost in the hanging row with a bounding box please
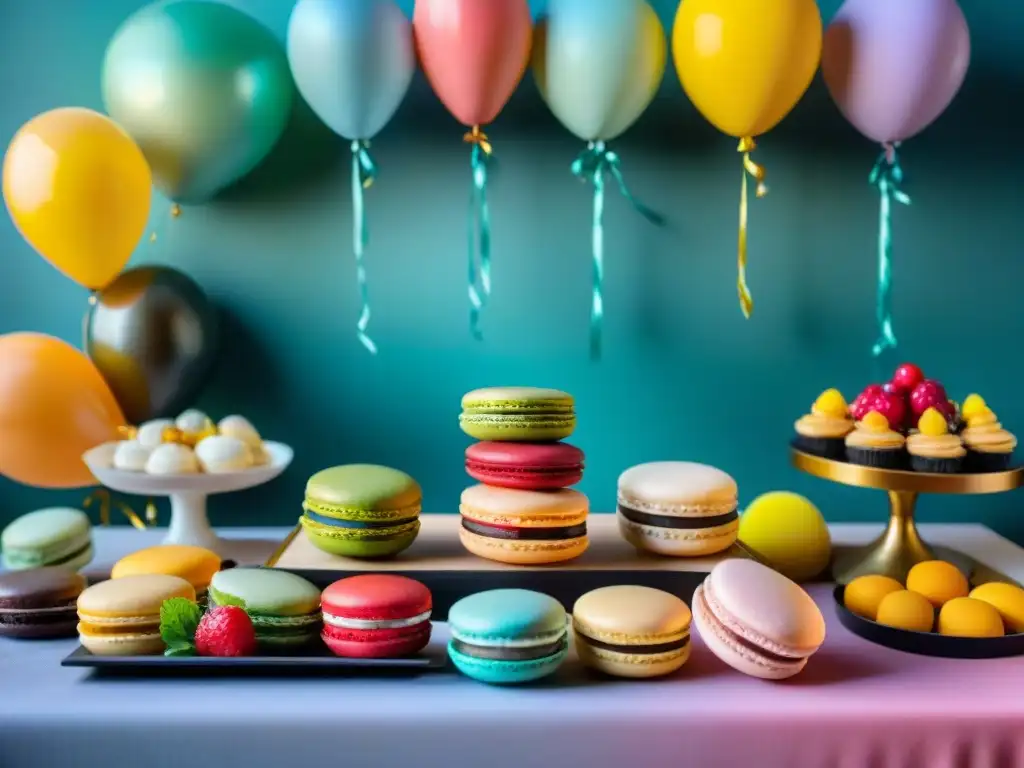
[821,0,971,142]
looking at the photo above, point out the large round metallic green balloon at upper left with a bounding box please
[102,0,294,203]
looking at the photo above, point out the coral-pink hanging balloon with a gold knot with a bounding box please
[413,0,532,126]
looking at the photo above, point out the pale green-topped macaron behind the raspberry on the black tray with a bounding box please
[208,568,322,650]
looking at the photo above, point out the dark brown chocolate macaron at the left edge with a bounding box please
[0,566,86,639]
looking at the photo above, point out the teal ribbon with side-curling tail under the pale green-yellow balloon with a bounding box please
[571,141,665,360]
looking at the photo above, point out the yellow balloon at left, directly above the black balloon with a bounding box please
[3,108,153,289]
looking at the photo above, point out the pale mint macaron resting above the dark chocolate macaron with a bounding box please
[0,507,92,570]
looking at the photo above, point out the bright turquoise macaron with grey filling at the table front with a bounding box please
[447,590,568,685]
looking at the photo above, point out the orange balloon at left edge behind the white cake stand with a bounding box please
[0,333,125,488]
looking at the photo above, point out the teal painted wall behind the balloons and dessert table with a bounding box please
[0,0,1024,541]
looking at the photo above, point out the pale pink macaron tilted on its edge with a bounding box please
[693,559,825,680]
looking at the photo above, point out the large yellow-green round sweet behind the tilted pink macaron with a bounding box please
[739,490,831,582]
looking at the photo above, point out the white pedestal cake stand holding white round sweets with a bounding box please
[82,442,294,554]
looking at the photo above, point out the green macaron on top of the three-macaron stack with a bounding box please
[459,387,575,442]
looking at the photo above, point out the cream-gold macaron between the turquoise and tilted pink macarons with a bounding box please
[572,585,691,678]
